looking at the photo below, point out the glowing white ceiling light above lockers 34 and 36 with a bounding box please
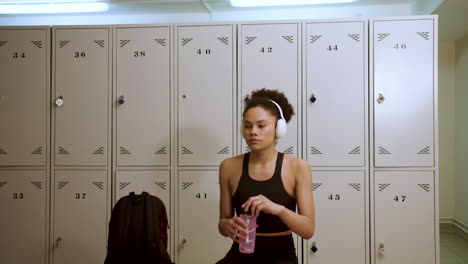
[0,3,109,14]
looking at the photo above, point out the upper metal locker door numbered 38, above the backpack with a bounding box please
[114,27,171,166]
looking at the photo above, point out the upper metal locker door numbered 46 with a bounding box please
[371,19,437,167]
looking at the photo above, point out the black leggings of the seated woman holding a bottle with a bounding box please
[216,235,298,264]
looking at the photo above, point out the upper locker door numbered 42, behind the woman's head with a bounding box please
[241,23,301,156]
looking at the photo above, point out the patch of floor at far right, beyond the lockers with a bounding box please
[440,225,468,264]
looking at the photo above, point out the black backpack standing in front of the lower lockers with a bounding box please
[104,192,173,264]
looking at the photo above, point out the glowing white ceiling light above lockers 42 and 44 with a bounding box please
[231,0,357,7]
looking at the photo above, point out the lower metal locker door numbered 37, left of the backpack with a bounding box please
[51,170,109,264]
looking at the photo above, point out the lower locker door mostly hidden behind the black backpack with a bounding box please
[115,171,171,252]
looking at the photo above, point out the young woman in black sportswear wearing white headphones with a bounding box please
[217,89,315,264]
